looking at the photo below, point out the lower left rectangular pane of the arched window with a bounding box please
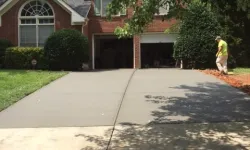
[20,25,36,46]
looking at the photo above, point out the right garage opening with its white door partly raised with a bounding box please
[140,33,177,68]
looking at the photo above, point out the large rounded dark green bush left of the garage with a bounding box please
[44,29,88,70]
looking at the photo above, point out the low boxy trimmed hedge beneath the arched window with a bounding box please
[4,47,47,69]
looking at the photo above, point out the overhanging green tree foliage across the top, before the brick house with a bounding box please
[107,0,250,36]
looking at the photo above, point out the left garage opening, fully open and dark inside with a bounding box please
[94,35,134,69]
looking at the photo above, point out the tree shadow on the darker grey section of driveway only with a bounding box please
[145,83,250,124]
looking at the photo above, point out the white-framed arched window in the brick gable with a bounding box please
[19,0,55,47]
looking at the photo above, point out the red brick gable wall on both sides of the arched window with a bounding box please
[0,0,82,45]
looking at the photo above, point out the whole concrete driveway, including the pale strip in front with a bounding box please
[0,69,250,150]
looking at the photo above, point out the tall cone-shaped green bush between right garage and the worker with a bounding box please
[174,2,221,68]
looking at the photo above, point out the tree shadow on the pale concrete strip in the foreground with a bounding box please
[78,123,250,150]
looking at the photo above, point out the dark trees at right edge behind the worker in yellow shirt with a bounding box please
[202,0,250,67]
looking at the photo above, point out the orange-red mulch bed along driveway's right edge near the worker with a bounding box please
[201,70,250,95]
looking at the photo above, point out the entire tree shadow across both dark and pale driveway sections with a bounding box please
[78,83,250,150]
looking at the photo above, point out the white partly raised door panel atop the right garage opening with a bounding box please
[141,33,177,43]
